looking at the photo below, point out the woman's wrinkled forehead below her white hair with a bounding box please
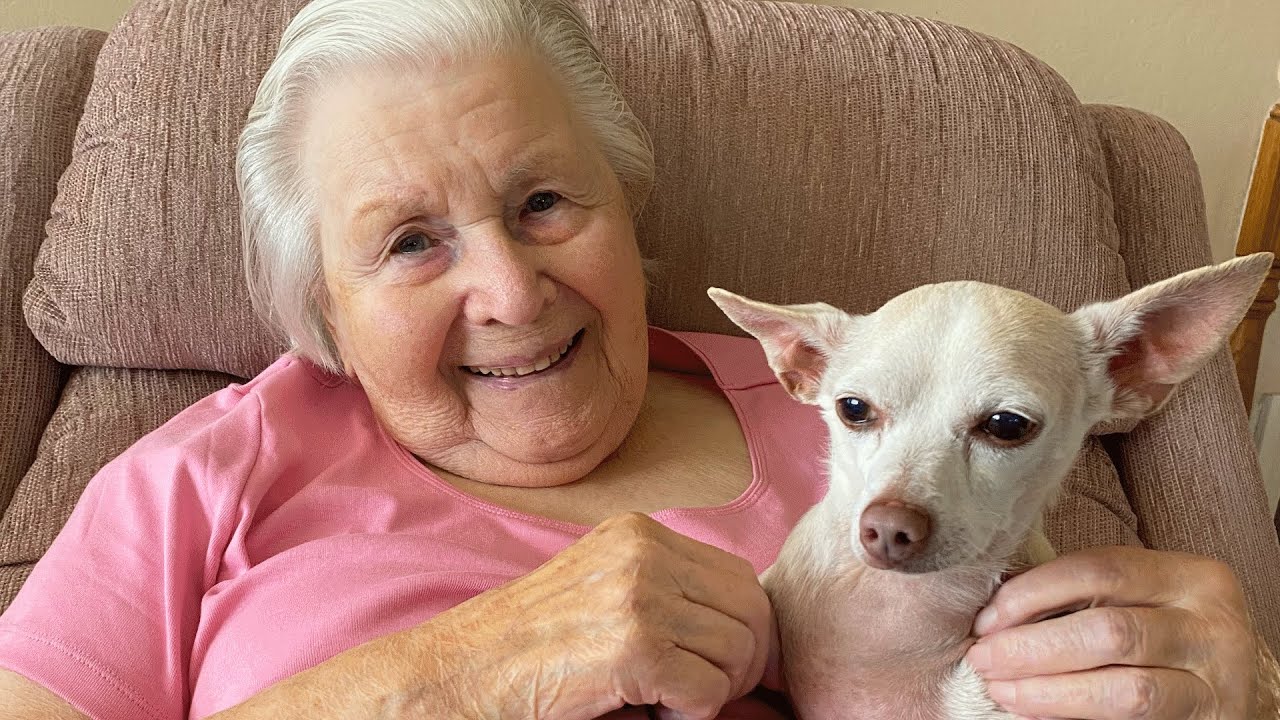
[306,59,599,215]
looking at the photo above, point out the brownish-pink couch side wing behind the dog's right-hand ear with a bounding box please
[1088,105,1280,650]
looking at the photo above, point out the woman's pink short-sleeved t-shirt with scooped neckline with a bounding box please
[0,331,826,720]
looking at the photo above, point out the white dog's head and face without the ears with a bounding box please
[817,283,1093,573]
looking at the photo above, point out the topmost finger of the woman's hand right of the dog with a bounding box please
[974,547,1201,637]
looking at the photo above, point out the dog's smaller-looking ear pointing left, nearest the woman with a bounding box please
[707,287,849,405]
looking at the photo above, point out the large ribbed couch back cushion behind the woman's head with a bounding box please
[27,0,1126,375]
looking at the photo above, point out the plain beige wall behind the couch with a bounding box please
[0,0,1280,392]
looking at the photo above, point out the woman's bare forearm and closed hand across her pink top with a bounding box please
[215,514,772,720]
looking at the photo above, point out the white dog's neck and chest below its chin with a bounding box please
[769,502,1019,719]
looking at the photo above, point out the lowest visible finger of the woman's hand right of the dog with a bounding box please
[987,666,1211,720]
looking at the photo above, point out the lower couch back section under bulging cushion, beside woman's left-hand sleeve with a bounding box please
[0,368,236,611]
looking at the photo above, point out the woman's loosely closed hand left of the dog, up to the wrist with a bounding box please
[424,514,772,720]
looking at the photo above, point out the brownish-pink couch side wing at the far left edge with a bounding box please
[0,28,106,510]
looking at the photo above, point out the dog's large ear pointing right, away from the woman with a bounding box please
[1074,252,1272,420]
